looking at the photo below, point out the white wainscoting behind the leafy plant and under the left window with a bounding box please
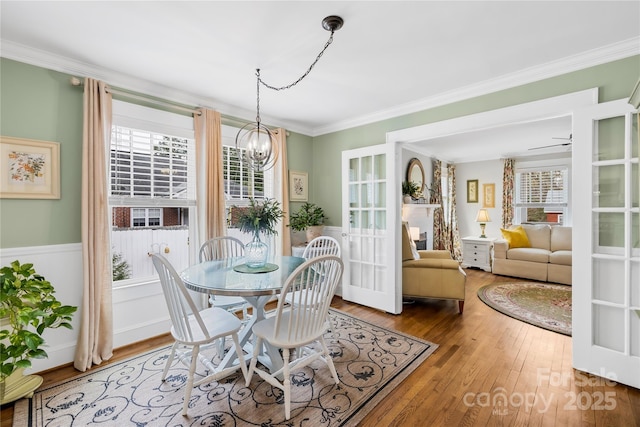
[0,243,170,372]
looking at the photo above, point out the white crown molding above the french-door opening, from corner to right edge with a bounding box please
[311,37,640,137]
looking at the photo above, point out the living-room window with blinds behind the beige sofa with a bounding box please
[514,166,569,225]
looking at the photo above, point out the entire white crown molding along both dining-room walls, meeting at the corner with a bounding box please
[1,37,640,137]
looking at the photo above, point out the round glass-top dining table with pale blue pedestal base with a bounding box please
[180,256,306,372]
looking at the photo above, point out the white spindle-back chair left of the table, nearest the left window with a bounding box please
[151,254,247,416]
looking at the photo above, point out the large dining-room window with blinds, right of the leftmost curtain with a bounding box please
[109,101,196,286]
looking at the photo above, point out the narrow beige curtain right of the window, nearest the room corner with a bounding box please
[273,128,291,255]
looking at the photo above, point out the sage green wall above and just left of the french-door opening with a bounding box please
[309,56,640,226]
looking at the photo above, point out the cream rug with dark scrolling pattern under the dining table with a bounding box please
[13,309,438,427]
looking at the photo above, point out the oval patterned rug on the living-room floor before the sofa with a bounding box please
[478,282,571,336]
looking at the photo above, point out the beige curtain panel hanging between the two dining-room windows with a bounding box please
[194,109,227,243]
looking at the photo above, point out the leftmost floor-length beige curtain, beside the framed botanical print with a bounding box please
[73,78,113,371]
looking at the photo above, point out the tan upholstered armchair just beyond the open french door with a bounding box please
[402,222,467,314]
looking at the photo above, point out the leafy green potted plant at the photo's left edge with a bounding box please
[0,261,77,404]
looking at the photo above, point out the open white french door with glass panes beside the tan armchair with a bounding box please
[342,144,402,314]
